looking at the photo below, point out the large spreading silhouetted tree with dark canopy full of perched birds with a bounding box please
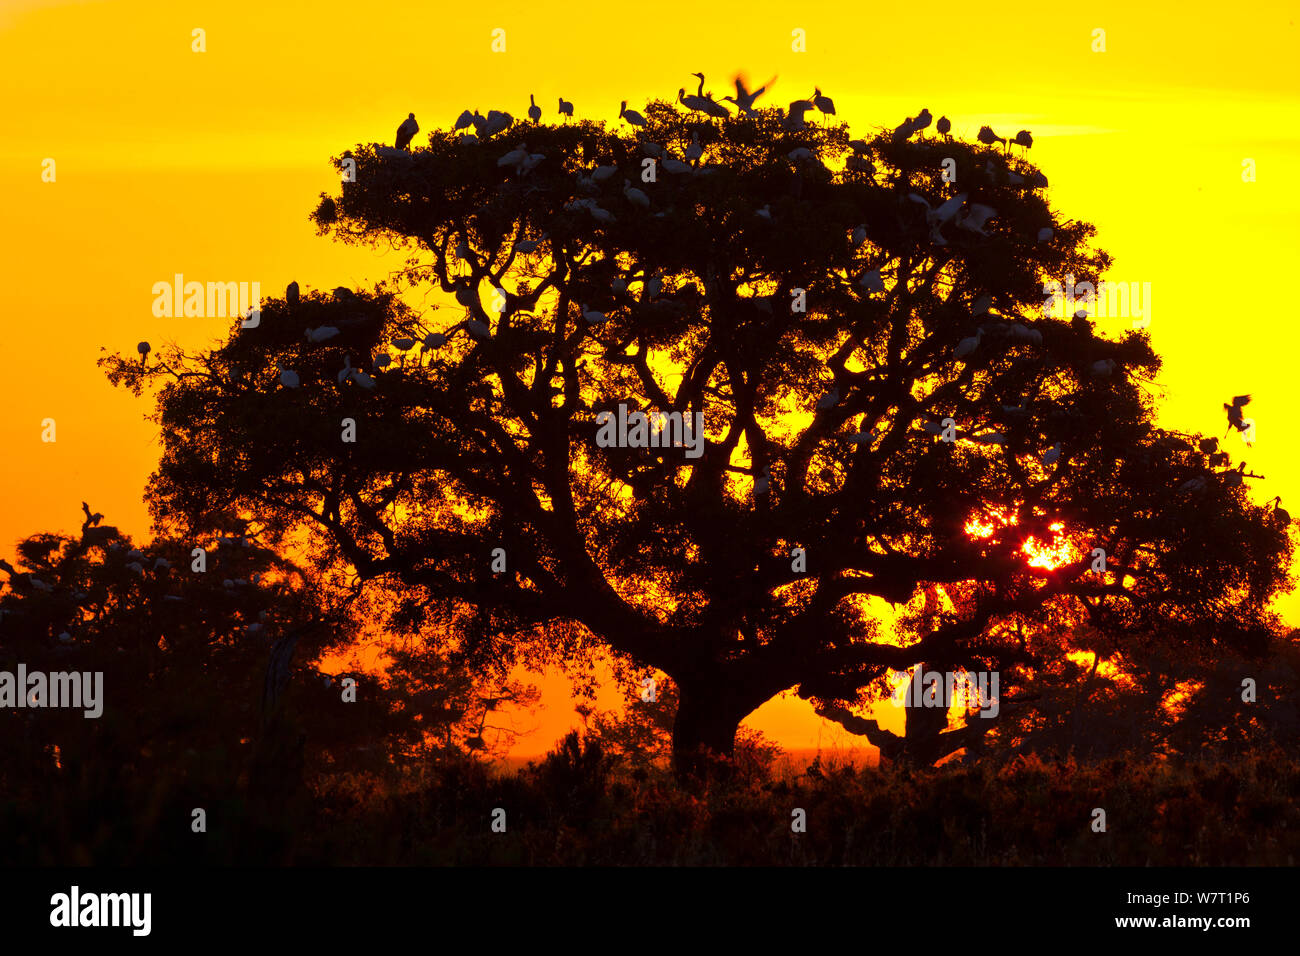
[113,89,1291,780]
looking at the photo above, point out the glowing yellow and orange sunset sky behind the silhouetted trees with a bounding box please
[0,0,1300,754]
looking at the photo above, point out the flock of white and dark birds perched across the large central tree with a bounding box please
[119,73,1284,530]
